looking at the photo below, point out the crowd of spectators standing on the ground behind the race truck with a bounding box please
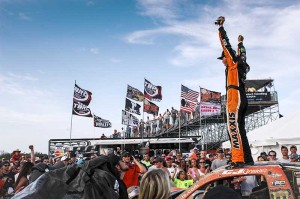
[0,145,299,198]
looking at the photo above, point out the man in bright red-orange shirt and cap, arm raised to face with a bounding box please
[122,152,147,188]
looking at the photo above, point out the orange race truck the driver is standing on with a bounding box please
[172,162,300,199]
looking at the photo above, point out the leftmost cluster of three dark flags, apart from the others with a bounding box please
[72,83,111,128]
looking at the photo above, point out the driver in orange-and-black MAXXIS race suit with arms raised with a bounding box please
[215,16,253,167]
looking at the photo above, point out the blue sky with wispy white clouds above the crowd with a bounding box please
[0,0,300,152]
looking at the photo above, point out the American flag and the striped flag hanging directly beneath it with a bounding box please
[180,85,199,113]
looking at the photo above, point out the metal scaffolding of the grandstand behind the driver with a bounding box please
[158,79,280,150]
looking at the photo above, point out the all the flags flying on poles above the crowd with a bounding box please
[72,79,221,128]
